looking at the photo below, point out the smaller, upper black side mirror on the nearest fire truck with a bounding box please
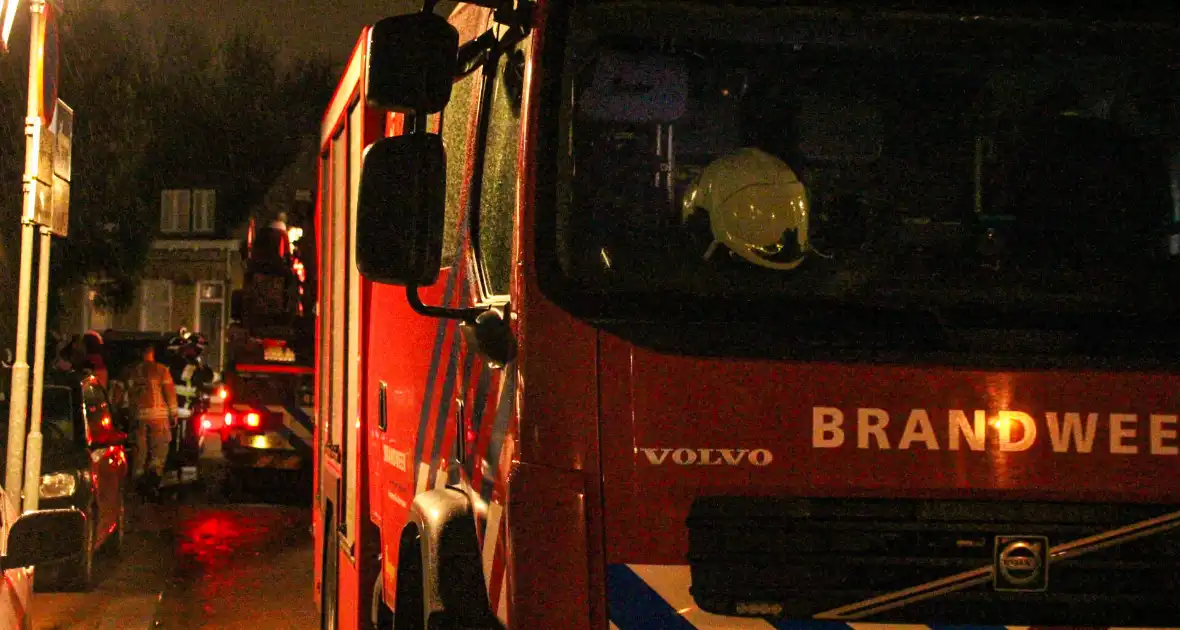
[365,13,459,113]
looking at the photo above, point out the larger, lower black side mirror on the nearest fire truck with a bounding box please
[356,133,446,287]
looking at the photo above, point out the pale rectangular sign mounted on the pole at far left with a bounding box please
[33,99,73,237]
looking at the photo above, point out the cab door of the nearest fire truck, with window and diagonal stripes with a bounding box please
[451,21,531,622]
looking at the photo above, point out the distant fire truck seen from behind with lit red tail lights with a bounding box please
[202,217,314,483]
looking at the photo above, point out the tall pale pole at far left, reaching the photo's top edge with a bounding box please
[5,0,45,511]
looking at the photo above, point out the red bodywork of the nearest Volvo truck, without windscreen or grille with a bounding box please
[314,4,1180,630]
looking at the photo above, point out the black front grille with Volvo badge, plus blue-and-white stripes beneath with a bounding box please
[607,497,1180,630]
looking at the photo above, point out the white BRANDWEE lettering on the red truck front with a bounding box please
[812,407,1180,455]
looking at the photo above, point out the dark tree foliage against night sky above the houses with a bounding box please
[0,4,334,309]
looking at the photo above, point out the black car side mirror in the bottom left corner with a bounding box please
[0,510,86,570]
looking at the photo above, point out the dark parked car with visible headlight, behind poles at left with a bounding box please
[0,372,130,591]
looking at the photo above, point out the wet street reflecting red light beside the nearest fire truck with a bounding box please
[33,460,319,630]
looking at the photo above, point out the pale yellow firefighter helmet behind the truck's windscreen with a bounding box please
[682,147,811,270]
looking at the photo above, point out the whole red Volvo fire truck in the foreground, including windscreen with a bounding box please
[314,0,1180,630]
